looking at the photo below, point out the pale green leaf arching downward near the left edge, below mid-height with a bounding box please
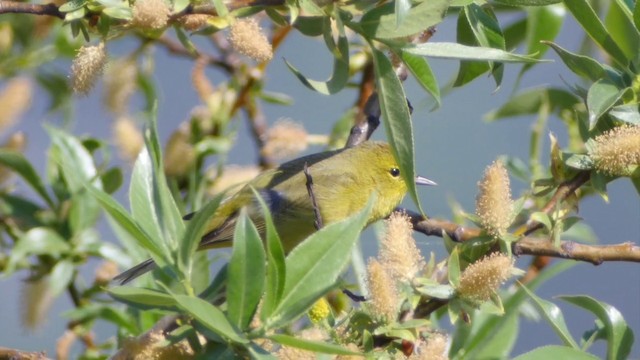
[4,227,71,276]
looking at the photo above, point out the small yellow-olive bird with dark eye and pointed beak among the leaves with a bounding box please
[115,141,435,284]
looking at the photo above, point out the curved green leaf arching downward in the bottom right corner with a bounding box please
[559,295,634,360]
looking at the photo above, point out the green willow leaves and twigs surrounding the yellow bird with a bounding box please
[0,0,640,359]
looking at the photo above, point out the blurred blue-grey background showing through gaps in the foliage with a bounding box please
[0,8,640,359]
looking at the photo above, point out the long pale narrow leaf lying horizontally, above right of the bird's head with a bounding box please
[402,42,542,63]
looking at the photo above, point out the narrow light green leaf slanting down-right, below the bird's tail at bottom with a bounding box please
[173,294,249,344]
